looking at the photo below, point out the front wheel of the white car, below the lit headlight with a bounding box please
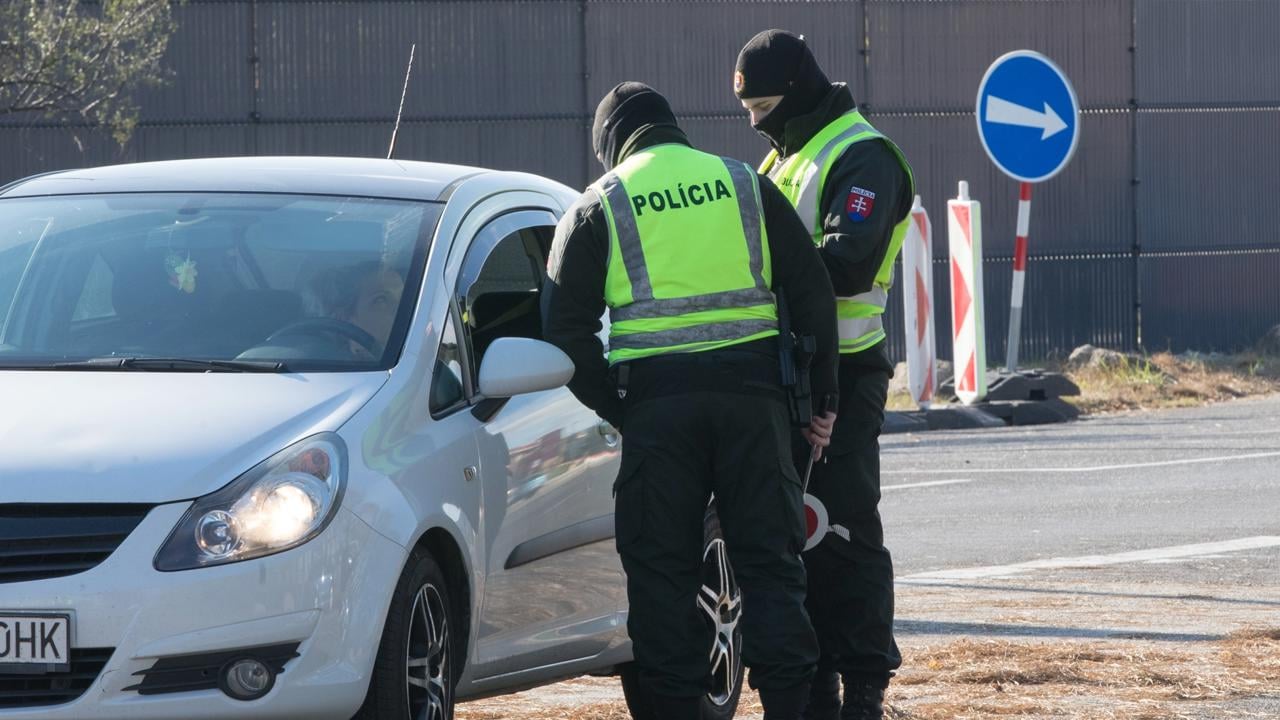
[352,551,465,720]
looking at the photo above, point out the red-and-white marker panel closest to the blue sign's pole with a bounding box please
[947,181,987,405]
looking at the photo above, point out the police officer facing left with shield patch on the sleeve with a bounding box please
[733,29,915,720]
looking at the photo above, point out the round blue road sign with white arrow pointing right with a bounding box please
[977,50,1080,182]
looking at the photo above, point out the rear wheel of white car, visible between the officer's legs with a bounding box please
[618,505,746,720]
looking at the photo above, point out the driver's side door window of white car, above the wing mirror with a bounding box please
[458,211,556,377]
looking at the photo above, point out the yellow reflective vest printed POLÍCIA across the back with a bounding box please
[591,143,778,365]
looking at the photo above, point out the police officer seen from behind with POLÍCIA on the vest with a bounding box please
[543,82,837,720]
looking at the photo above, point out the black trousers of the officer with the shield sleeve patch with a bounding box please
[796,361,902,687]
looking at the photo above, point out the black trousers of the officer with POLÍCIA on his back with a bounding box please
[614,351,818,697]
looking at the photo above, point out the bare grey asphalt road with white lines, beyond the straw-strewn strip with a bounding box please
[881,397,1280,583]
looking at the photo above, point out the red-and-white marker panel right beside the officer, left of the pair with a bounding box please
[902,195,938,410]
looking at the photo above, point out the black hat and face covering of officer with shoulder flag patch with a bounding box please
[733,29,831,149]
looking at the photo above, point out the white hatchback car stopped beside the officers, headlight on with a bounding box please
[0,158,742,720]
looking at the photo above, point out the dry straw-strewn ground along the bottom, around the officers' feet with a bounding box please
[458,626,1280,720]
